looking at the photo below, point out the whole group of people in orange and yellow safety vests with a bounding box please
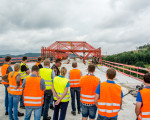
[1,56,150,120]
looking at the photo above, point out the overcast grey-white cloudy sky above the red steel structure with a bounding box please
[0,0,150,54]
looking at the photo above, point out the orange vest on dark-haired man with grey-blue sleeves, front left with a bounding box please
[23,76,44,106]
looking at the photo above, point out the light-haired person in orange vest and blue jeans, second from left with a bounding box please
[3,63,24,120]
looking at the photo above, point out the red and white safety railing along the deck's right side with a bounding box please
[102,60,148,80]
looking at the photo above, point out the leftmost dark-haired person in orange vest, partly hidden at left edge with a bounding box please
[1,56,13,115]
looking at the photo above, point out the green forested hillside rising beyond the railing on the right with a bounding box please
[103,44,150,67]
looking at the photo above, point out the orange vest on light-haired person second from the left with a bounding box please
[7,72,23,95]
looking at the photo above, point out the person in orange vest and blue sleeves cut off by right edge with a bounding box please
[135,73,150,120]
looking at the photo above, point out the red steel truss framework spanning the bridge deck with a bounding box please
[41,41,101,63]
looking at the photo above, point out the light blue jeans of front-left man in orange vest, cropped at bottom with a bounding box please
[24,106,42,120]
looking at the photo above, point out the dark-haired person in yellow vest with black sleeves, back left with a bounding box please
[19,56,30,109]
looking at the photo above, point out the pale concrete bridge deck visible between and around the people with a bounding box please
[0,60,141,120]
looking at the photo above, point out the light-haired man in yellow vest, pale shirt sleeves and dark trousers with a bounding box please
[39,60,55,120]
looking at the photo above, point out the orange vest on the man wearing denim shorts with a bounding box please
[80,75,99,104]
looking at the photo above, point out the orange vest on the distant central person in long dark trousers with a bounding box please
[69,69,81,87]
